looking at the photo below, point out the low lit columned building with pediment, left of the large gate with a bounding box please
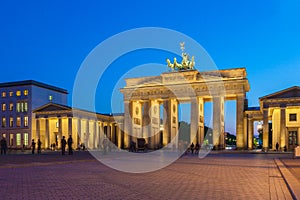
[33,102,124,150]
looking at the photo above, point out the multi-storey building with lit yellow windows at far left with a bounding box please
[0,80,68,148]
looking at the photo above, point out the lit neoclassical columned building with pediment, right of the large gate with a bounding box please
[244,86,300,150]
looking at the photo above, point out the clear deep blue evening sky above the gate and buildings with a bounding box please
[0,0,300,133]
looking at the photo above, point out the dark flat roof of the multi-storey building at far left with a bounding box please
[0,80,68,94]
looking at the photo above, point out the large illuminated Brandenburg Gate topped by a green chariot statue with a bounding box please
[120,46,250,148]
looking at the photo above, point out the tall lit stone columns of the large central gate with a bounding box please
[124,95,246,148]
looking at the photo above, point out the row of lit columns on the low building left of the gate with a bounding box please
[33,116,123,149]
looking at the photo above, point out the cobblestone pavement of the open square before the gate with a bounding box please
[0,152,292,200]
